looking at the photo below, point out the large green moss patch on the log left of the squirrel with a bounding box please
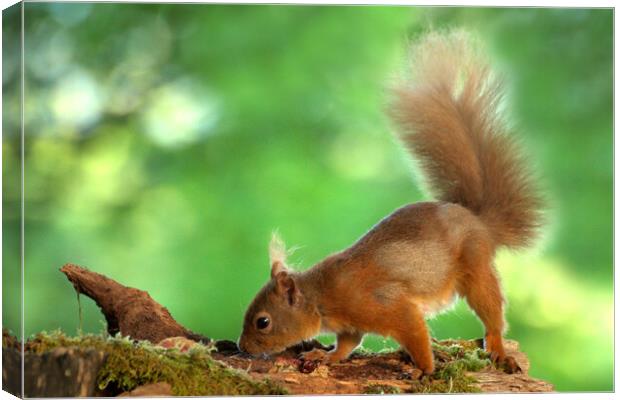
[27,332,286,396]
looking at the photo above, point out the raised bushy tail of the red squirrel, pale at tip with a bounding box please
[390,31,542,248]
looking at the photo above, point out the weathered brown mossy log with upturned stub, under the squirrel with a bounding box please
[3,264,553,397]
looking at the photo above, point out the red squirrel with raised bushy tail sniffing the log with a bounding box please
[238,31,543,375]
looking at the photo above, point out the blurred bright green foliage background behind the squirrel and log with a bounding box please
[2,3,613,391]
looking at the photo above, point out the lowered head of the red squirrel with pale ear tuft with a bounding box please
[239,235,321,355]
